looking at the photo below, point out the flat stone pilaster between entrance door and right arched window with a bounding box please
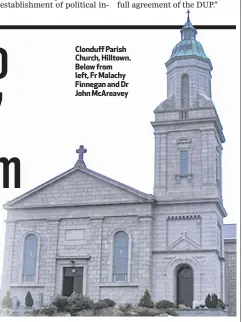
[87,217,103,301]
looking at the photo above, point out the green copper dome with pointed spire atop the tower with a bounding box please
[169,12,209,60]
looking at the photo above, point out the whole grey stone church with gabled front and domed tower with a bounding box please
[2,17,236,314]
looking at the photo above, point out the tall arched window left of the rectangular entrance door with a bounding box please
[22,234,38,282]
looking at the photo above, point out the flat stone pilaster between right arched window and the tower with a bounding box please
[138,216,153,296]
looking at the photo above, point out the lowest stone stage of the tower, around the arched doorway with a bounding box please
[152,203,224,306]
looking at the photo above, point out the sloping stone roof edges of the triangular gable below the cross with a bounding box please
[3,164,154,210]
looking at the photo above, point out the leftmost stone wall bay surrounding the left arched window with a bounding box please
[4,220,58,303]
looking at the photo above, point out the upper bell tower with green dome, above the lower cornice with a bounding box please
[152,13,225,202]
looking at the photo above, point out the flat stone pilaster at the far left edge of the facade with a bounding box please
[1,221,15,296]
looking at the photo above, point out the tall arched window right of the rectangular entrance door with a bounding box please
[113,231,129,282]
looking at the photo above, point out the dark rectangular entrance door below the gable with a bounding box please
[62,267,83,296]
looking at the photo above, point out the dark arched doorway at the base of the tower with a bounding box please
[176,264,193,307]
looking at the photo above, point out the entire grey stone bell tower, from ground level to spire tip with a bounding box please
[152,14,227,306]
